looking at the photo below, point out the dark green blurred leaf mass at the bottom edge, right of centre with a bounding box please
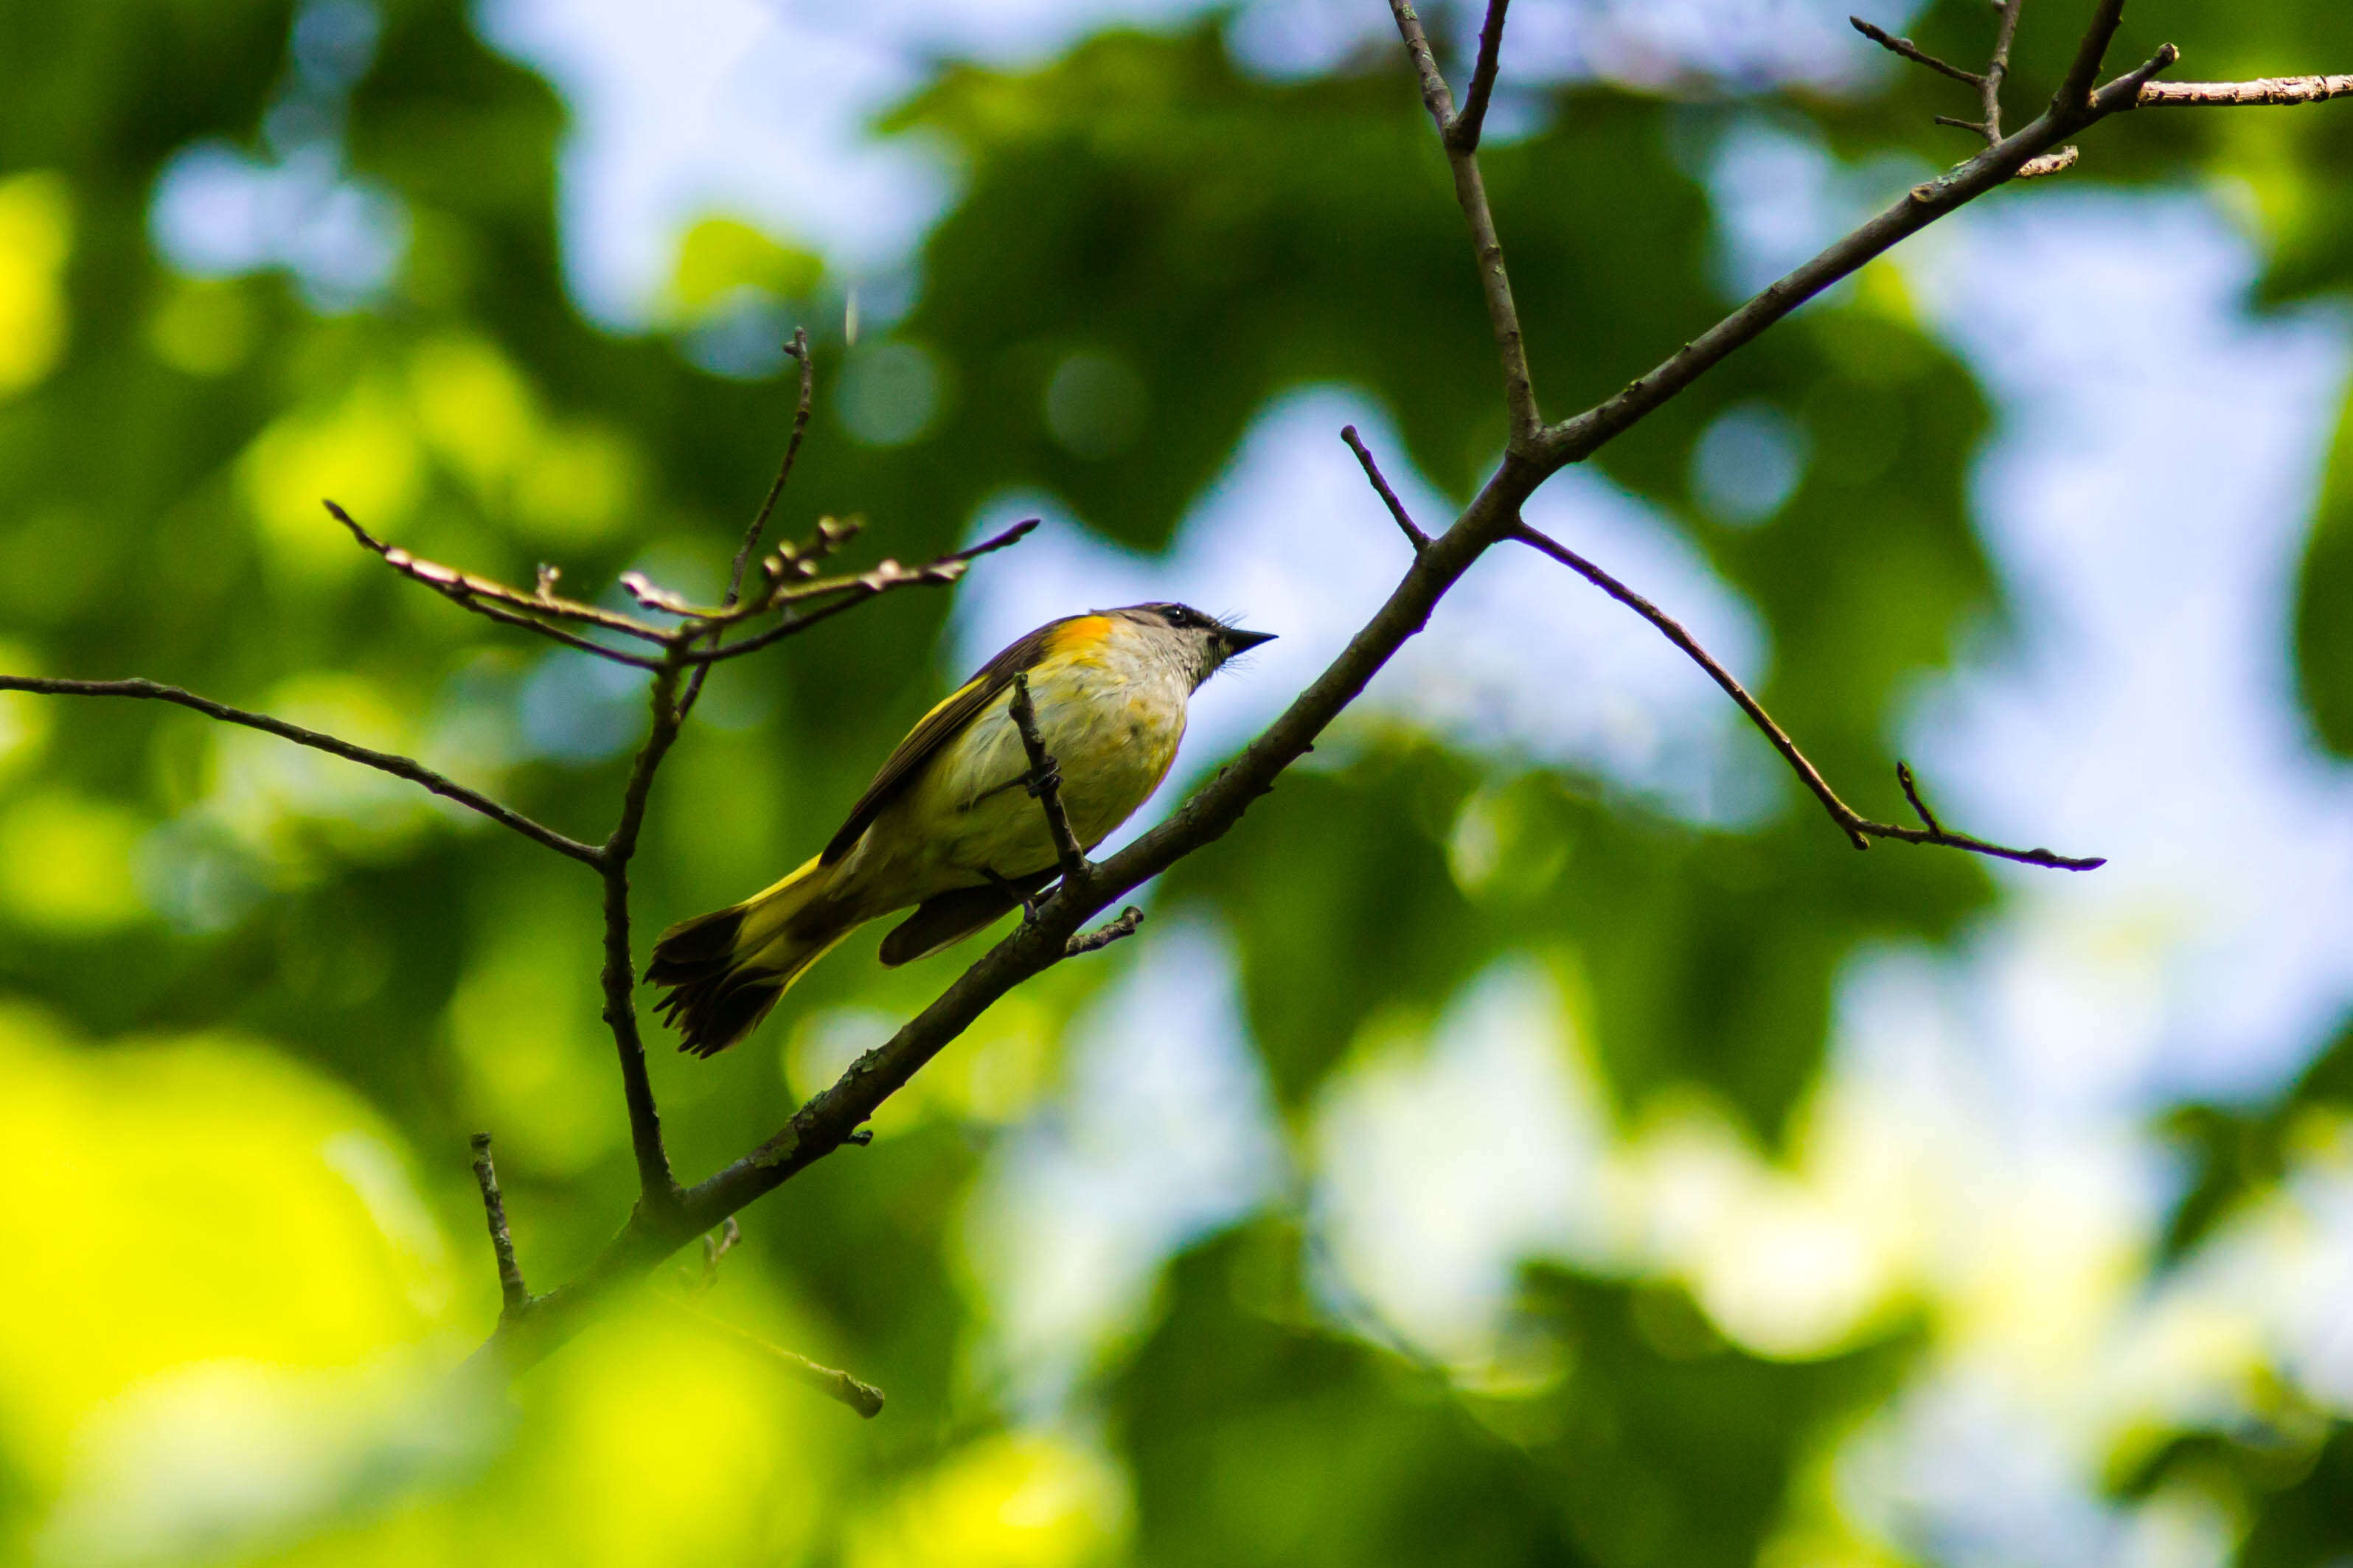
[1113,1227,1908,1568]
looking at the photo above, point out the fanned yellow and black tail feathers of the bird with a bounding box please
[644,860,852,1056]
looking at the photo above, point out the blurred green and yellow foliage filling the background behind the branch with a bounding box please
[0,0,2353,1568]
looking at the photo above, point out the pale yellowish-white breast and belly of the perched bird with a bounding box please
[845,658,1191,914]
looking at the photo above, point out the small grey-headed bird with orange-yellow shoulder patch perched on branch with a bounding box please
[644,604,1273,1056]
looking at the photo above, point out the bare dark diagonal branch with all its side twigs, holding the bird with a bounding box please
[0,0,2353,1413]
